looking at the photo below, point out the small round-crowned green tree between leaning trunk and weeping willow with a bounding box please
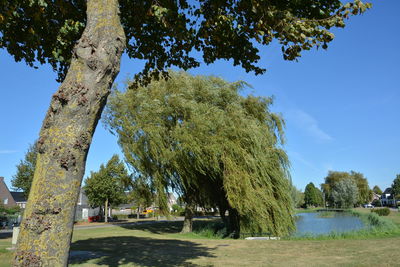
[83,155,128,222]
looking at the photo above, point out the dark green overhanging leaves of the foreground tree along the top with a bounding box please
[0,0,371,81]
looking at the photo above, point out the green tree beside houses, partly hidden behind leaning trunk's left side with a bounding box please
[11,141,38,197]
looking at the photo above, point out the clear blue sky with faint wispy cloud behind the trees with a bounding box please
[0,0,400,193]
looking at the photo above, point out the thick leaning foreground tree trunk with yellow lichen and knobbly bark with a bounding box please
[14,0,126,266]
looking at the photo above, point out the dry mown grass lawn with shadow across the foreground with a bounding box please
[0,209,400,266]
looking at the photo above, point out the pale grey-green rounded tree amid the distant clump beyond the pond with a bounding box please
[332,179,358,208]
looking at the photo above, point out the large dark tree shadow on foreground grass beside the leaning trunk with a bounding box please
[69,236,214,267]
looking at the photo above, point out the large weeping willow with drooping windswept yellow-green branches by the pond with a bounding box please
[105,72,294,235]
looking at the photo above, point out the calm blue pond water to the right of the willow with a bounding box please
[295,212,364,236]
